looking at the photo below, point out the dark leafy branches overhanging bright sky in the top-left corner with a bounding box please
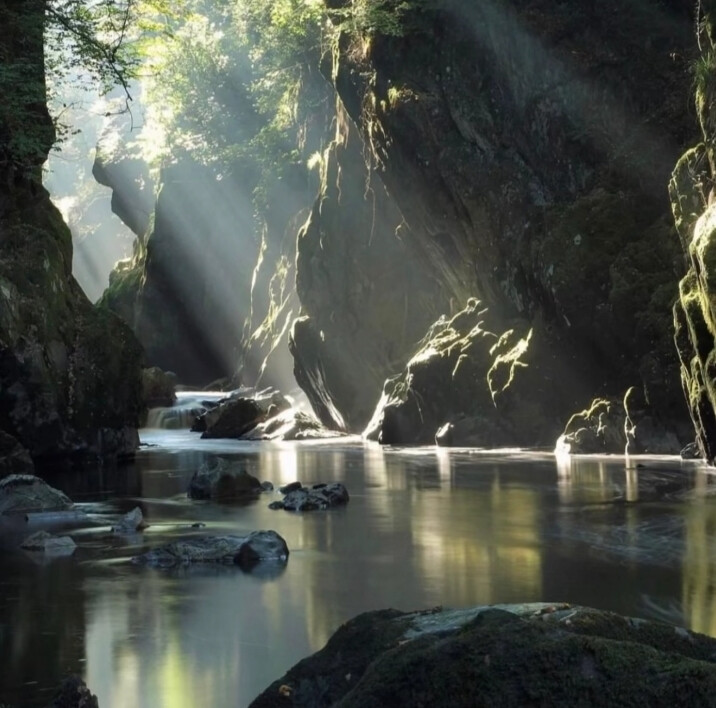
[0,0,137,172]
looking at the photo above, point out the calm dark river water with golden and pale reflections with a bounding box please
[0,430,716,708]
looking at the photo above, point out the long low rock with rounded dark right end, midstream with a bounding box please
[132,531,289,568]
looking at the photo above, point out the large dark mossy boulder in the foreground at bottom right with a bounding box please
[251,603,716,708]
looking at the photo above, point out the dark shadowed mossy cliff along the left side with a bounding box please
[0,0,142,460]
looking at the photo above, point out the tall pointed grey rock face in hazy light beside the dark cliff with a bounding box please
[289,106,449,431]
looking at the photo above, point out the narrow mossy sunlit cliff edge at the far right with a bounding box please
[669,2,716,464]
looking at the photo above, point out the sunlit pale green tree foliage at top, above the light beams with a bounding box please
[133,0,425,194]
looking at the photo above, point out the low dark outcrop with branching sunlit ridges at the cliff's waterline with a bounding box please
[366,298,592,447]
